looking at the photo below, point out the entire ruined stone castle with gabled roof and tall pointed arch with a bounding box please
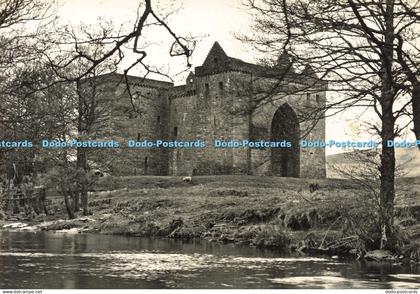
[91,42,326,178]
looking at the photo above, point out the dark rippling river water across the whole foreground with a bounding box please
[0,231,420,289]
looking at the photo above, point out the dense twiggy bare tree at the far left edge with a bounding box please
[0,0,55,181]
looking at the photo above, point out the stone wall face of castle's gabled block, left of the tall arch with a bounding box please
[170,73,253,175]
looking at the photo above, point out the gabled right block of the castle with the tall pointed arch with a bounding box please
[169,42,326,177]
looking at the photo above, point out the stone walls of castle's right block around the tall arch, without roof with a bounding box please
[169,72,326,178]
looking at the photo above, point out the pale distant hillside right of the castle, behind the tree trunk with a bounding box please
[327,148,420,178]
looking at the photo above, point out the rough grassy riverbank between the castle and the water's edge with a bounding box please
[0,176,420,260]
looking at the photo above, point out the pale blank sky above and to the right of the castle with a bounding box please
[59,0,413,154]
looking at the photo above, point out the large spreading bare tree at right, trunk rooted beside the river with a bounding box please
[244,0,420,248]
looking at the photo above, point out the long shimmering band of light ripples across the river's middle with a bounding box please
[0,252,330,279]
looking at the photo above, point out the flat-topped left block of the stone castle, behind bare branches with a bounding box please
[90,74,173,175]
